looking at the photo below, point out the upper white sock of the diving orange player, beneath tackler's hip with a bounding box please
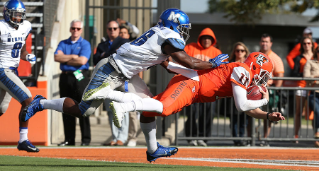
[106,91,142,103]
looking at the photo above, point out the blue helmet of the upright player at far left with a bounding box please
[3,0,26,27]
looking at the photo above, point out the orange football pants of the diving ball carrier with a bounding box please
[142,75,200,117]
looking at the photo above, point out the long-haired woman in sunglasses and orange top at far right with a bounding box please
[292,37,315,143]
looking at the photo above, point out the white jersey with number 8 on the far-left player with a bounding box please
[0,20,31,68]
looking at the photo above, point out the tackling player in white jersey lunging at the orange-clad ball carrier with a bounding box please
[22,9,228,161]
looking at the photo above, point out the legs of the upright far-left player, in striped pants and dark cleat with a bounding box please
[0,68,39,152]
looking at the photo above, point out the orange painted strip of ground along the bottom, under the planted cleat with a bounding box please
[0,147,319,170]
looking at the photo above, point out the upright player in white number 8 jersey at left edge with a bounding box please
[0,0,39,152]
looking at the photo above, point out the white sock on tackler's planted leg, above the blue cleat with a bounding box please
[140,121,157,154]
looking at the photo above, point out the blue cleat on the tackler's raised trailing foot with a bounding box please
[20,95,46,122]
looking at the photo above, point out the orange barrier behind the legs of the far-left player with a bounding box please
[0,81,49,146]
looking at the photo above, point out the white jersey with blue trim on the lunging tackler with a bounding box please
[113,26,185,78]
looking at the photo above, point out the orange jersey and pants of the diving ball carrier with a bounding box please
[143,62,253,117]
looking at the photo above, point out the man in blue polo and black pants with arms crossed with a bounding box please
[54,20,91,146]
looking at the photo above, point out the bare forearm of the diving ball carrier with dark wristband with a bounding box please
[245,108,285,121]
